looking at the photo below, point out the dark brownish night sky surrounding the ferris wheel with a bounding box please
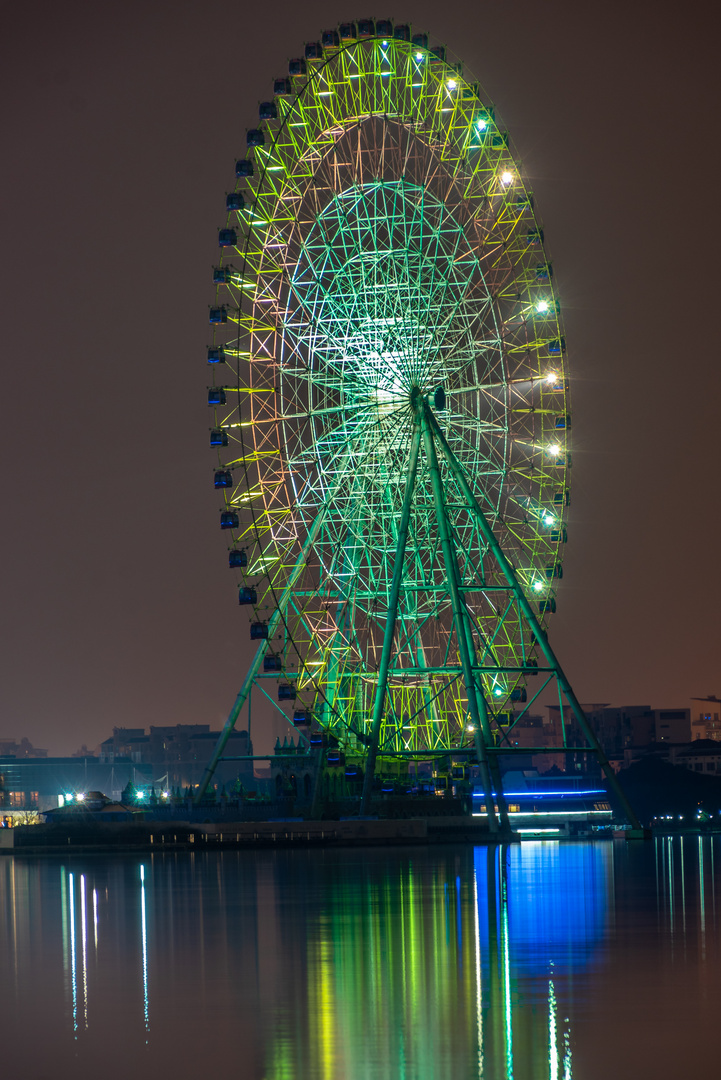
[0,0,721,754]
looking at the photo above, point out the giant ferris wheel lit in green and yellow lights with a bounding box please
[199,21,638,825]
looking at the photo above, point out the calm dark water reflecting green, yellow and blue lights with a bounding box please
[0,837,721,1080]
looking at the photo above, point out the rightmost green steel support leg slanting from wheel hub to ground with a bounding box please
[424,403,641,829]
